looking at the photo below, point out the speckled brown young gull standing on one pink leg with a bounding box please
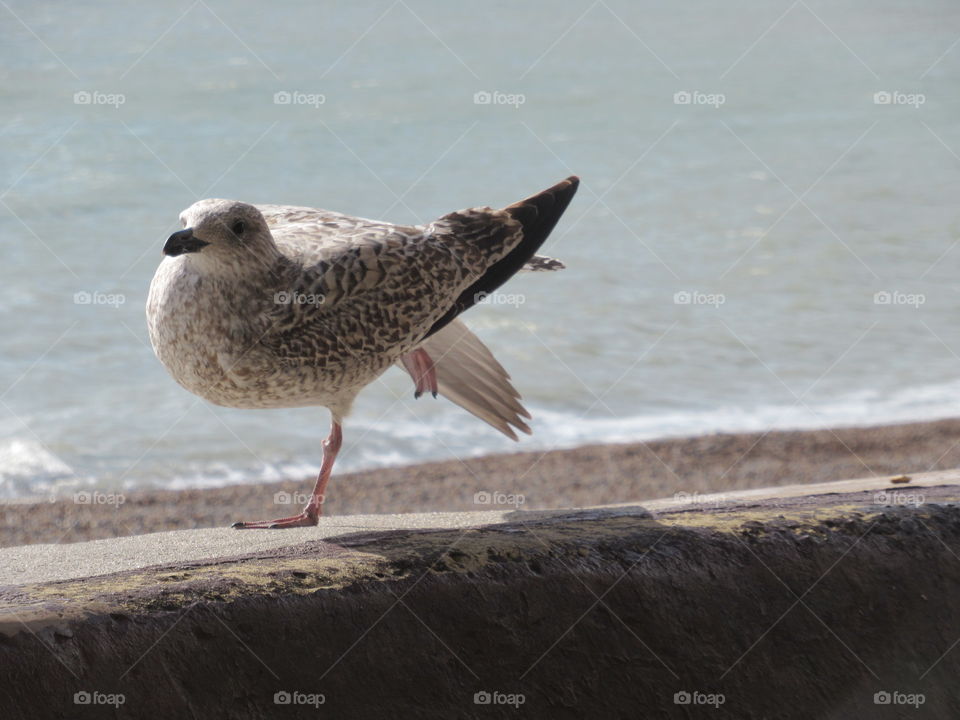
[147,177,579,528]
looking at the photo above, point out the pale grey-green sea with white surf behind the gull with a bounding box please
[0,0,960,498]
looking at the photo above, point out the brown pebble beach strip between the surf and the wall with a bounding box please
[0,419,960,547]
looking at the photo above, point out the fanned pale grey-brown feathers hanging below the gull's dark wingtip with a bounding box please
[397,320,532,440]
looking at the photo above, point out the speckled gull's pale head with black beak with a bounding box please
[163,200,276,266]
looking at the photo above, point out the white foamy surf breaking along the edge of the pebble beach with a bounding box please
[0,380,960,500]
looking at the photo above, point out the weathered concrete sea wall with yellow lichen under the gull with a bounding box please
[0,472,960,718]
